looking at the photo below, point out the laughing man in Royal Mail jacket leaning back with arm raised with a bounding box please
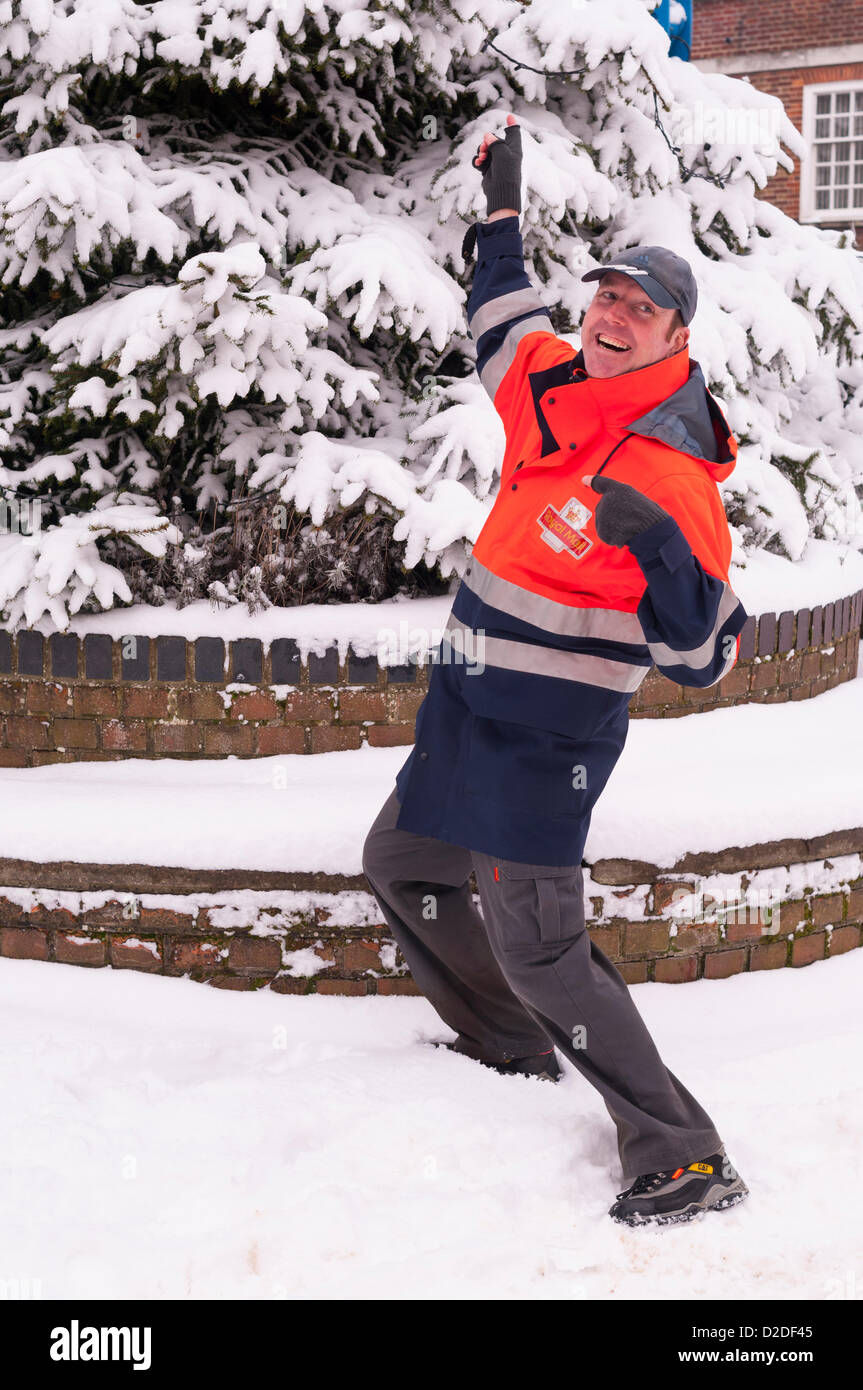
[363,117,748,1225]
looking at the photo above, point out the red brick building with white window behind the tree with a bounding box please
[692,0,863,250]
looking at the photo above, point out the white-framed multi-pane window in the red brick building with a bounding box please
[800,81,863,222]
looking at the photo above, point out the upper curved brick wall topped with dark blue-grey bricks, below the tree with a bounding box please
[0,589,863,767]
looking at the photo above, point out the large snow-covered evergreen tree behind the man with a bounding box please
[0,0,863,628]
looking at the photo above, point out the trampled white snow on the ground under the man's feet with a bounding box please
[0,951,863,1301]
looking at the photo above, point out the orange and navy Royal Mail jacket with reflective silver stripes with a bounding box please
[396,217,748,866]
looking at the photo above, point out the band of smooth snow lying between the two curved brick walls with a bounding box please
[0,639,863,874]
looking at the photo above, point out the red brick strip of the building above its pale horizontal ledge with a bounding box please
[692,0,863,61]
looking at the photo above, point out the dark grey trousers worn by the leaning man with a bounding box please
[363,788,721,1186]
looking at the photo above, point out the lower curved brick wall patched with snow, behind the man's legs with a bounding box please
[0,828,863,995]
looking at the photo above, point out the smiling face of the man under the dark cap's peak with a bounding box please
[581,270,689,377]
